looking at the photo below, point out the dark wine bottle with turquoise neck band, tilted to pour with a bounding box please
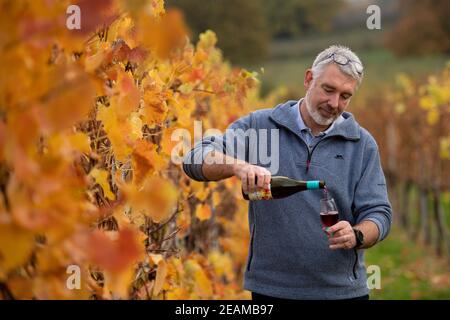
[242,176,325,201]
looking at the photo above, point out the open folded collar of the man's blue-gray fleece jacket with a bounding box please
[270,100,360,141]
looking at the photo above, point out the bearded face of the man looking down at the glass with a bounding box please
[304,63,357,126]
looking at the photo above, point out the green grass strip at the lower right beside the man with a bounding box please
[366,226,450,300]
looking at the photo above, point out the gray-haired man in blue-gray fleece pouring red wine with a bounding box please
[183,46,392,299]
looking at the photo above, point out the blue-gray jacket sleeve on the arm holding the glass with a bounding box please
[353,138,392,241]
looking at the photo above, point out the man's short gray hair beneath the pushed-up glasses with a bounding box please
[311,45,364,86]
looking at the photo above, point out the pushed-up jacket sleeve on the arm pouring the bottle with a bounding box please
[183,114,252,181]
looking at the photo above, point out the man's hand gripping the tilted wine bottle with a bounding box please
[233,163,272,194]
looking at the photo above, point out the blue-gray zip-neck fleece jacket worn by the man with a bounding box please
[183,101,392,299]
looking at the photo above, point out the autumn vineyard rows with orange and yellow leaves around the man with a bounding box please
[0,0,450,300]
